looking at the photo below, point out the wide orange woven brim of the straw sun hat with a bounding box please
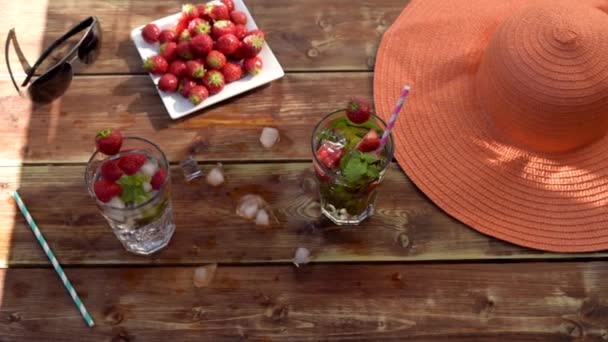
[374,0,608,252]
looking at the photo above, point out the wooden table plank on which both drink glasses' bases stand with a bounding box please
[0,163,608,266]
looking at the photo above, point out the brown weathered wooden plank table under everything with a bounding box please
[0,0,608,341]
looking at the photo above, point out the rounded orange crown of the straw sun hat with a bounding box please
[476,1,608,153]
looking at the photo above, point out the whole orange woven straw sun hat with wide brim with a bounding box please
[374,0,608,252]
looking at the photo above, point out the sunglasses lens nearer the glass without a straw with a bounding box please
[28,63,72,103]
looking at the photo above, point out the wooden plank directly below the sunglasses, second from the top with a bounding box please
[0,73,372,165]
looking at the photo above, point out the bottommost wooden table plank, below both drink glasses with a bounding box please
[0,263,608,342]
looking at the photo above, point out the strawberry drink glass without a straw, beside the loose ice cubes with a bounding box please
[85,129,175,255]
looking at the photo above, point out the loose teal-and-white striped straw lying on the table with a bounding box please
[13,191,95,328]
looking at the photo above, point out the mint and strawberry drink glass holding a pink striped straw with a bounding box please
[312,98,393,225]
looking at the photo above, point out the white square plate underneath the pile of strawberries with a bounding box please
[131,0,285,119]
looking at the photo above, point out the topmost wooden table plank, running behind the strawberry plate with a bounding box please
[0,0,408,73]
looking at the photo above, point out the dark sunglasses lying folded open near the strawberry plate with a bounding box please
[4,17,101,103]
